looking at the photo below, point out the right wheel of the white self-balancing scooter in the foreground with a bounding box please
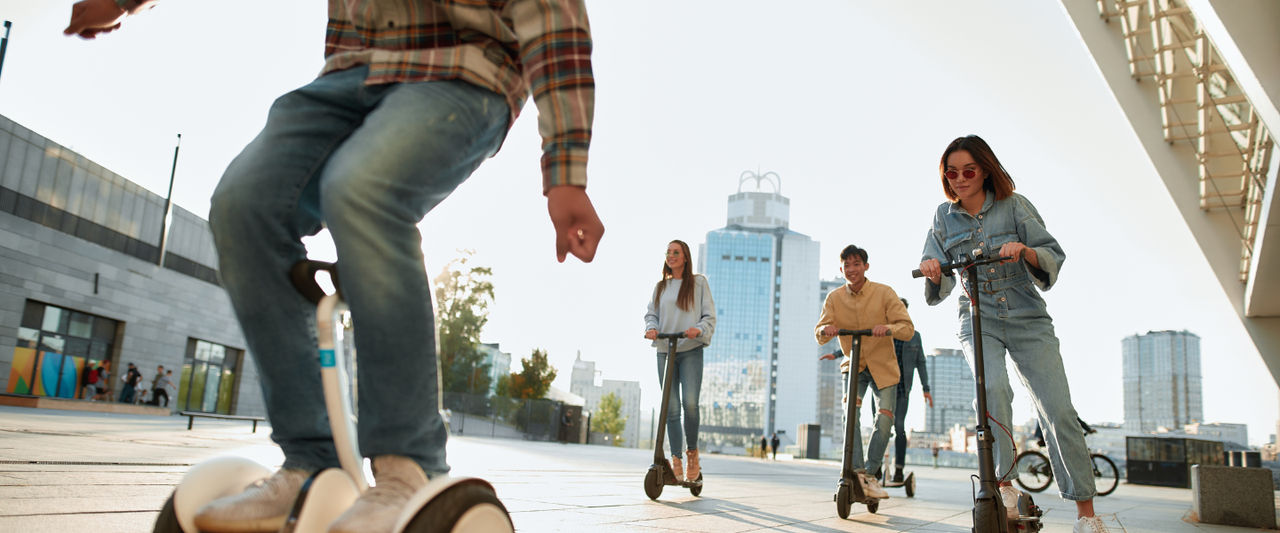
[404,483,516,533]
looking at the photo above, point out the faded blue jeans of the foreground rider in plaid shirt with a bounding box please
[209,67,508,475]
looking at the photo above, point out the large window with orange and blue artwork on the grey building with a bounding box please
[6,300,120,398]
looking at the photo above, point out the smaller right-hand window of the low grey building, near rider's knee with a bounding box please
[178,338,244,415]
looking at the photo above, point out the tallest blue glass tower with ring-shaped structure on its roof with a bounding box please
[698,170,820,451]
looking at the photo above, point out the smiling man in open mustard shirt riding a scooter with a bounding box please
[814,245,915,498]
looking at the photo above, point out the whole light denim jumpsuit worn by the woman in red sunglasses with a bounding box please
[922,191,1096,501]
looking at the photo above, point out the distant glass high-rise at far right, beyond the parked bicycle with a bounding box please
[1120,331,1204,433]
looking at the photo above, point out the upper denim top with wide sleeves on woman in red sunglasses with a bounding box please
[922,191,1066,322]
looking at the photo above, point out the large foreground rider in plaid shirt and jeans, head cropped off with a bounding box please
[64,0,604,532]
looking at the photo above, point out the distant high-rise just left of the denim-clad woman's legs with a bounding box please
[924,349,977,434]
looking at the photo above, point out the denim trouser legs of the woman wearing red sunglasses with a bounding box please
[960,315,1097,501]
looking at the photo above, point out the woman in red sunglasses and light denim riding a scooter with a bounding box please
[920,135,1107,533]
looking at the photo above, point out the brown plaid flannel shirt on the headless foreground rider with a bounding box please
[321,0,595,193]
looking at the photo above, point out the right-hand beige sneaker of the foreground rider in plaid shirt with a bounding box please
[329,455,426,533]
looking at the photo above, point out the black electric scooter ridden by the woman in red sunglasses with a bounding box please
[911,249,1044,533]
